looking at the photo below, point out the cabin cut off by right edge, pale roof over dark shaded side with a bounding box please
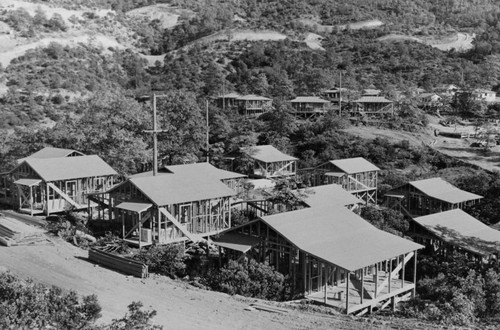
[408,209,500,260]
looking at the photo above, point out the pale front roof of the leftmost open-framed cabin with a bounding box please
[20,155,118,181]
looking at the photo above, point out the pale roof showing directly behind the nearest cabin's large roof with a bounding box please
[297,184,364,207]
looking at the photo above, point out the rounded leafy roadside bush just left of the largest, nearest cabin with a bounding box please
[206,259,286,300]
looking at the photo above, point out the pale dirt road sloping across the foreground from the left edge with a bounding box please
[0,238,394,329]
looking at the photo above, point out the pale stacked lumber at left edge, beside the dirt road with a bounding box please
[0,216,50,246]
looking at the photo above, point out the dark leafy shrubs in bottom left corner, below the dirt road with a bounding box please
[0,272,162,330]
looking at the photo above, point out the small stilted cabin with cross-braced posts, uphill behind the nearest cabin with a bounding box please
[310,157,380,204]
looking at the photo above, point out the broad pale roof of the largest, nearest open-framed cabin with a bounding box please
[262,205,422,271]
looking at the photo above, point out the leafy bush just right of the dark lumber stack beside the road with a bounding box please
[134,244,186,279]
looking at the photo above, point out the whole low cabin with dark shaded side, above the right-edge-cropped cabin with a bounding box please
[385,178,483,217]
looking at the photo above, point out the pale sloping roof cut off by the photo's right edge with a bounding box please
[414,209,500,256]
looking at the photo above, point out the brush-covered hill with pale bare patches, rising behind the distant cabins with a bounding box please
[0,0,500,128]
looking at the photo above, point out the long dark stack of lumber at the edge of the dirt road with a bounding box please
[89,249,148,278]
